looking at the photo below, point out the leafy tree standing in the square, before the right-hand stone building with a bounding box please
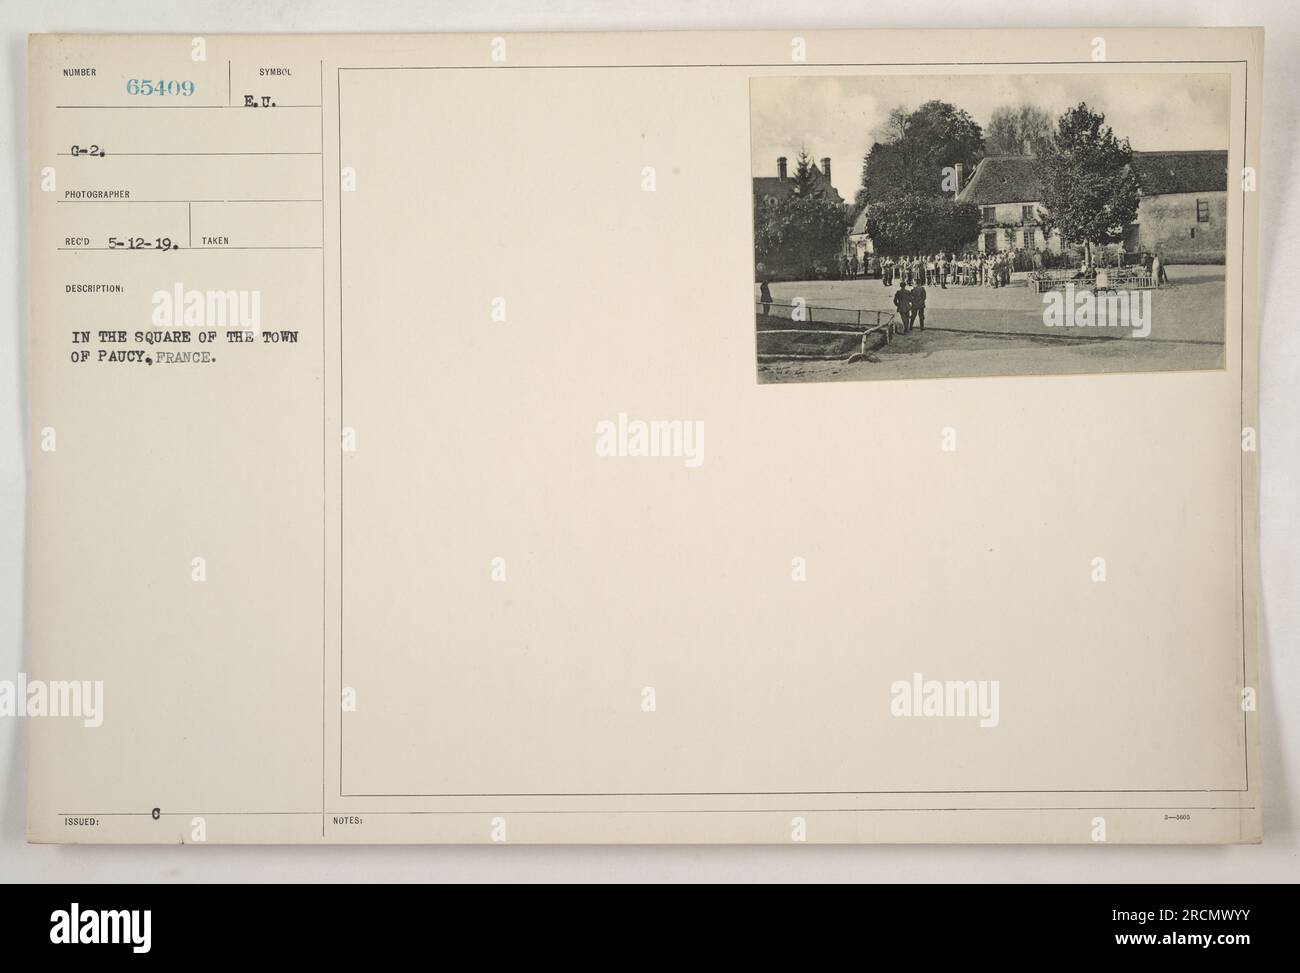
[1039,103,1138,255]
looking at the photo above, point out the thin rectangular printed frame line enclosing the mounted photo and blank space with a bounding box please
[332,57,1253,813]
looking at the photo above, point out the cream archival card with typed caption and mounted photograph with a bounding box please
[25,30,1262,843]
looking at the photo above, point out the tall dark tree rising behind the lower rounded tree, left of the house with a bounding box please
[857,101,984,206]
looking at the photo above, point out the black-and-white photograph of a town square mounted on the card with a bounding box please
[750,72,1227,382]
